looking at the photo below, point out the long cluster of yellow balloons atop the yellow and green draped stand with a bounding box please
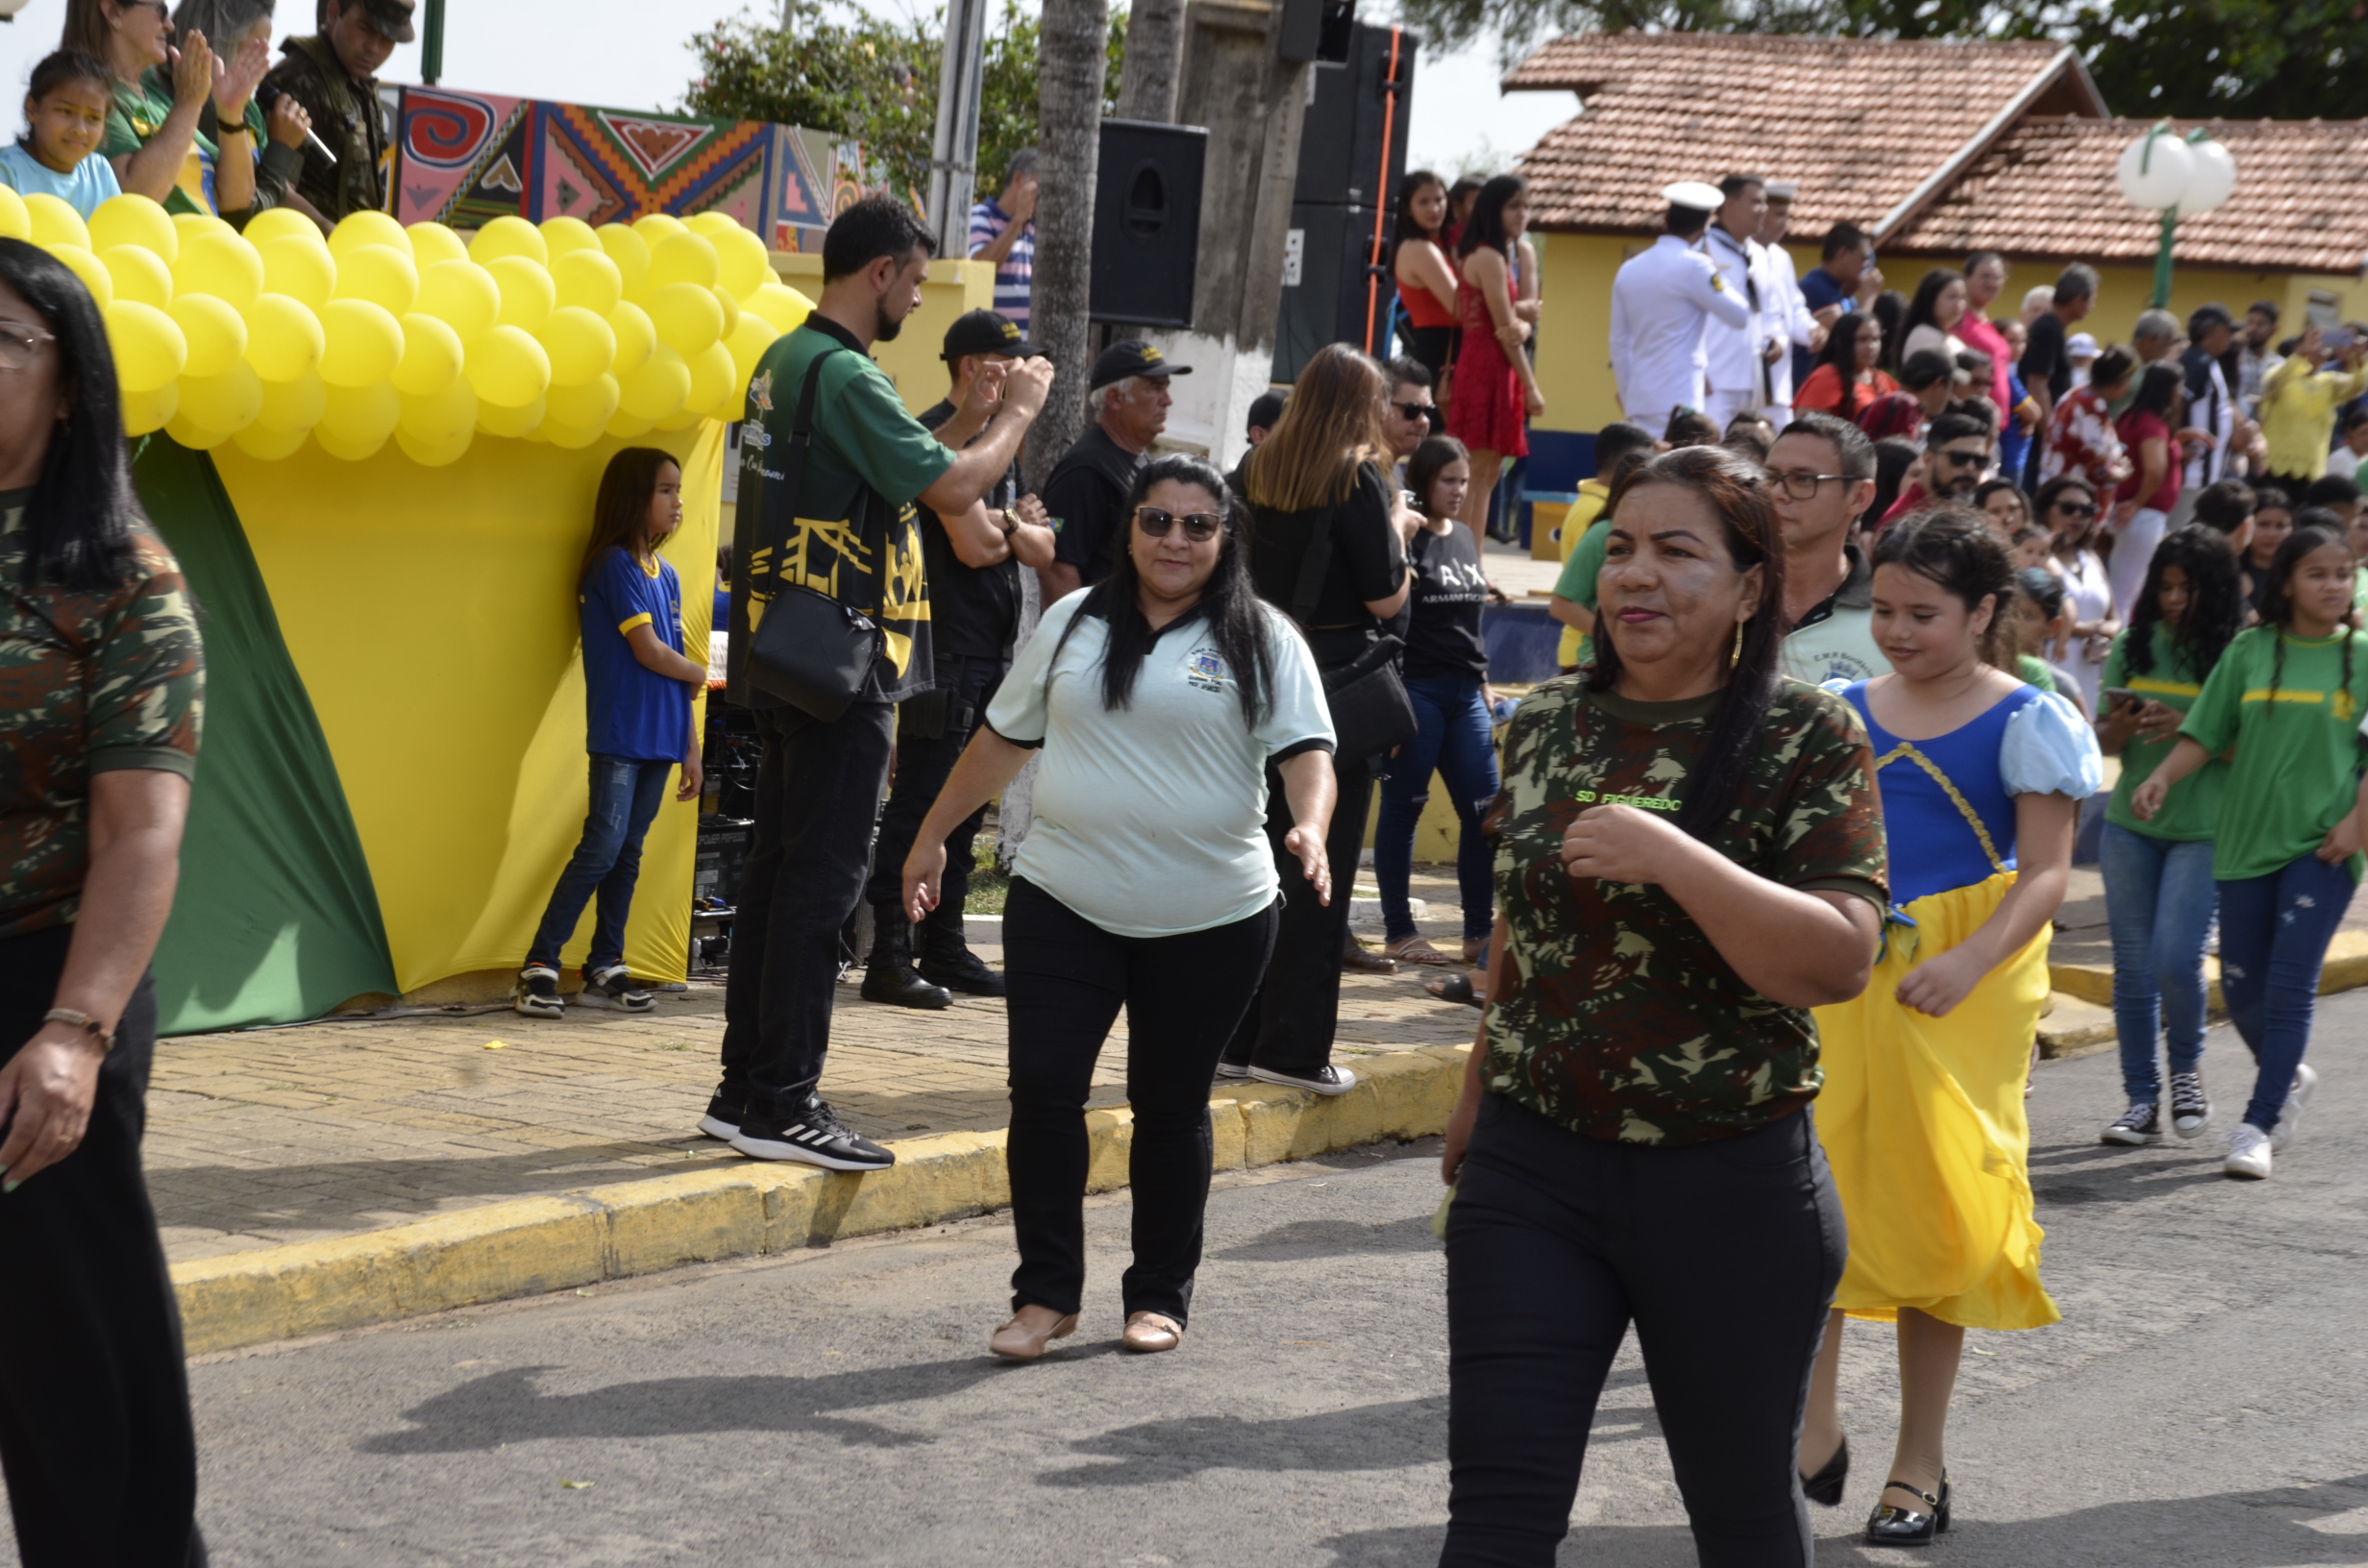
[0,187,812,467]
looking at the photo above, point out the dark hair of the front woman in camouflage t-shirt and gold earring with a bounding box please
[1587,448,1786,839]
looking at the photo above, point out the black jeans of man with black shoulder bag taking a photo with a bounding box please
[718,703,895,1115]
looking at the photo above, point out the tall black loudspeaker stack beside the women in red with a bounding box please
[1274,26,1416,381]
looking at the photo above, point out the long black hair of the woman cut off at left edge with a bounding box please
[0,239,147,592]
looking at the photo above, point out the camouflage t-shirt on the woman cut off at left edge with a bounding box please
[0,490,206,938]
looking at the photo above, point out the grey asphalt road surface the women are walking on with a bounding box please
[37,992,2368,1568]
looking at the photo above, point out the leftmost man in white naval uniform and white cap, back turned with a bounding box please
[1611,180,1750,441]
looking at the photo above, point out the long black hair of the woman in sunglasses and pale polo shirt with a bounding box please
[1051,453,1279,724]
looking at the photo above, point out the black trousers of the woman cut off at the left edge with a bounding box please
[0,928,206,1568]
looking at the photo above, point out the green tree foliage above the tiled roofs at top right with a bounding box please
[1399,0,2368,118]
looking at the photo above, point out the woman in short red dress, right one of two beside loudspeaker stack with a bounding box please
[1447,175,1546,543]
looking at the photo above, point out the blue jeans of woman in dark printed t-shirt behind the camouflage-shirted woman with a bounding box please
[1373,675,1496,943]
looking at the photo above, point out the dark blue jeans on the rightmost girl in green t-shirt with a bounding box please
[2221,855,2352,1132]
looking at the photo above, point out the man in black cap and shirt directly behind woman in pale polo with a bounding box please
[1037,339,1191,609]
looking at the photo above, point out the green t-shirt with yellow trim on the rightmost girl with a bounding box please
[2179,625,2368,881]
